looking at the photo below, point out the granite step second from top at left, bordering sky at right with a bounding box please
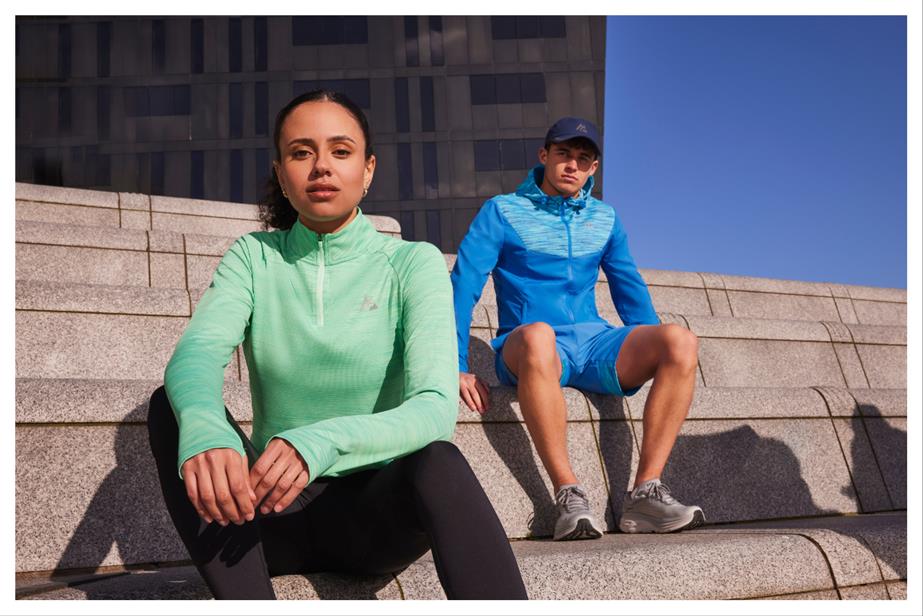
[16,216,907,327]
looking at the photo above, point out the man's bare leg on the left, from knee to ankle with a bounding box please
[503,323,577,493]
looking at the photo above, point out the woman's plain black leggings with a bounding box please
[148,387,527,599]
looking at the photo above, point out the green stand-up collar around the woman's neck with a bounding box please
[285,209,384,265]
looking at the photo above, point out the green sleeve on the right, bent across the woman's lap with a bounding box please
[276,242,458,481]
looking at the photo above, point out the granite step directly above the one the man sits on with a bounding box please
[16,280,907,389]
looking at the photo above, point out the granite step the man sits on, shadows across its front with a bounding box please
[16,379,907,571]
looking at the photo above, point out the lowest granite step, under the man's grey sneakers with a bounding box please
[16,513,907,599]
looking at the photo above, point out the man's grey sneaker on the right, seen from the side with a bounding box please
[619,479,705,533]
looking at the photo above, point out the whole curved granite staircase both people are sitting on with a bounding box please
[16,184,907,599]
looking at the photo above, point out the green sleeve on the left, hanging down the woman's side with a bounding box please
[164,238,253,477]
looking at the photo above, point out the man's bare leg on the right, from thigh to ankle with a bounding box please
[616,324,698,487]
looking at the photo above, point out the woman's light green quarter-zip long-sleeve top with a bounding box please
[164,211,458,481]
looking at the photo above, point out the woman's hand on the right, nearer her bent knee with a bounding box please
[250,438,309,515]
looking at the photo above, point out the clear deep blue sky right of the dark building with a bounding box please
[603,16,907,288]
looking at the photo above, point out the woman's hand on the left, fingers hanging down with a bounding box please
[183,447,257,526]
